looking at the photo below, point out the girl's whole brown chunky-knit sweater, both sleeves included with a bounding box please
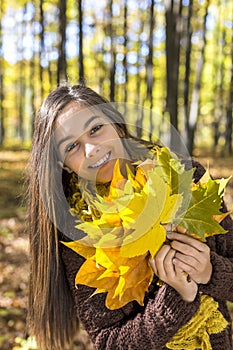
[60,163,233,350]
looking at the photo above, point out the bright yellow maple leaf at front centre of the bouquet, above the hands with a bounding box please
[121,169,182,257]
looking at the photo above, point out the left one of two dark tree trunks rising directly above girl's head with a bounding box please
[57,0,67,85]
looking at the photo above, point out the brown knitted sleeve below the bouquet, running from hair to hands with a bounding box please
[60,246,200,350]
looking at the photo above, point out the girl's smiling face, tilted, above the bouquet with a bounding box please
[55,102,127,183]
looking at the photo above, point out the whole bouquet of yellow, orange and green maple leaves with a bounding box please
[63,147,228,310]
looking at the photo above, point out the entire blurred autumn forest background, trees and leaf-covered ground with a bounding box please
[0,0,233,350]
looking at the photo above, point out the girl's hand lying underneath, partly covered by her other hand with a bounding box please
[150,244,198,302]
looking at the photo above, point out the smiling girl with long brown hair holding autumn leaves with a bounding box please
[28,85,233,350]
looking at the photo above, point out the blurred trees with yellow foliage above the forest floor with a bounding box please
[0,0,233,154]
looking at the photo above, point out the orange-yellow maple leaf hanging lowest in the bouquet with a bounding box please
[75,248,153,310]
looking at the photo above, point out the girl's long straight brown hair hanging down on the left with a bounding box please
[28,85,154,350]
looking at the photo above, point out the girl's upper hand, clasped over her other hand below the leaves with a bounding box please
[167,228,212,284]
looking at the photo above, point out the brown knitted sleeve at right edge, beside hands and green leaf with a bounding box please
[190,162,233,301]
